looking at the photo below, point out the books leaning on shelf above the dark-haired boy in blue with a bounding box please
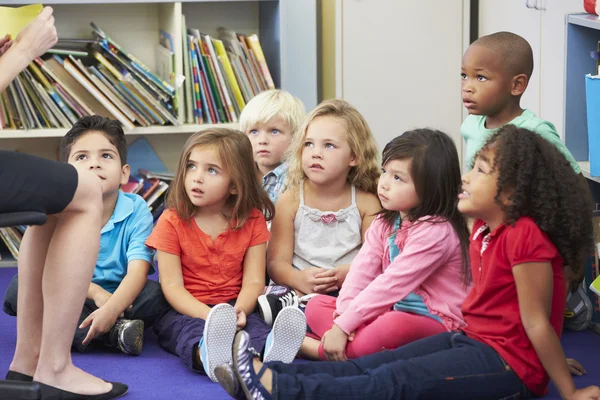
[0,23,178,130]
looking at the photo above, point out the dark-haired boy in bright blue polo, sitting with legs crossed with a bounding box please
[4,115,168,355]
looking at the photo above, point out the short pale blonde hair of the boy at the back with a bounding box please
[240,89,306,137]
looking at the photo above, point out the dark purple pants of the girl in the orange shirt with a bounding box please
[153,302,271,374]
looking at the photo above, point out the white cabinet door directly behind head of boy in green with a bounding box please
[479,0,544,115]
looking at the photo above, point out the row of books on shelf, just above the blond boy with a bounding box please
[182,16,275,124]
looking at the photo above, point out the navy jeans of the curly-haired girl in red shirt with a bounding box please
[269,332,531,400]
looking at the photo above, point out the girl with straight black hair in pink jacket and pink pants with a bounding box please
[300,129,470,360]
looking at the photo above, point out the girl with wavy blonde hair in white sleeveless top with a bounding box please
[258,100,381,324]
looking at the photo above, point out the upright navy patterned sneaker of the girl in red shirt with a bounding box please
[233,331,271,400]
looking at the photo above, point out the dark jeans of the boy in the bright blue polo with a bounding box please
[3,275,170,353]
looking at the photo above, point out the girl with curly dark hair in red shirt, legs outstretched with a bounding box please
[218,125,600,400]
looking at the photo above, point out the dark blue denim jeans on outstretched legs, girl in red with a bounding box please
[273,333,530,400]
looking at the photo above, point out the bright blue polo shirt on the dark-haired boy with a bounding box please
[92,191,154,293]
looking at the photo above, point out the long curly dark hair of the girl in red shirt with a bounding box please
[480,125,593,272]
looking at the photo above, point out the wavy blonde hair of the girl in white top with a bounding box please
[286,99,381,194]
